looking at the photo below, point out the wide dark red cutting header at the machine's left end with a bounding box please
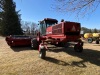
[5,35,32,47]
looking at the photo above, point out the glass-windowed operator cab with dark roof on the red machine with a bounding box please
[39,18,58,35]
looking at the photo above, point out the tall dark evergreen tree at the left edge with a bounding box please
[1,0,22,35]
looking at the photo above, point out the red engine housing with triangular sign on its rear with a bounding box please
[40,18,81,43]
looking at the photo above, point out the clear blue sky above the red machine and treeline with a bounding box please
[14,0,100,29]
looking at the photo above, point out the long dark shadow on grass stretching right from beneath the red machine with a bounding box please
[47,47,100,67]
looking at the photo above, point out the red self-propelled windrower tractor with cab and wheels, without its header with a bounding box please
[31,18,83,58]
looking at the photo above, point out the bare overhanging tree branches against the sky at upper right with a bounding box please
[53,0,100,16]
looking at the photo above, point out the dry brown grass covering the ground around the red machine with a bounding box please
[0,37,100,75]
